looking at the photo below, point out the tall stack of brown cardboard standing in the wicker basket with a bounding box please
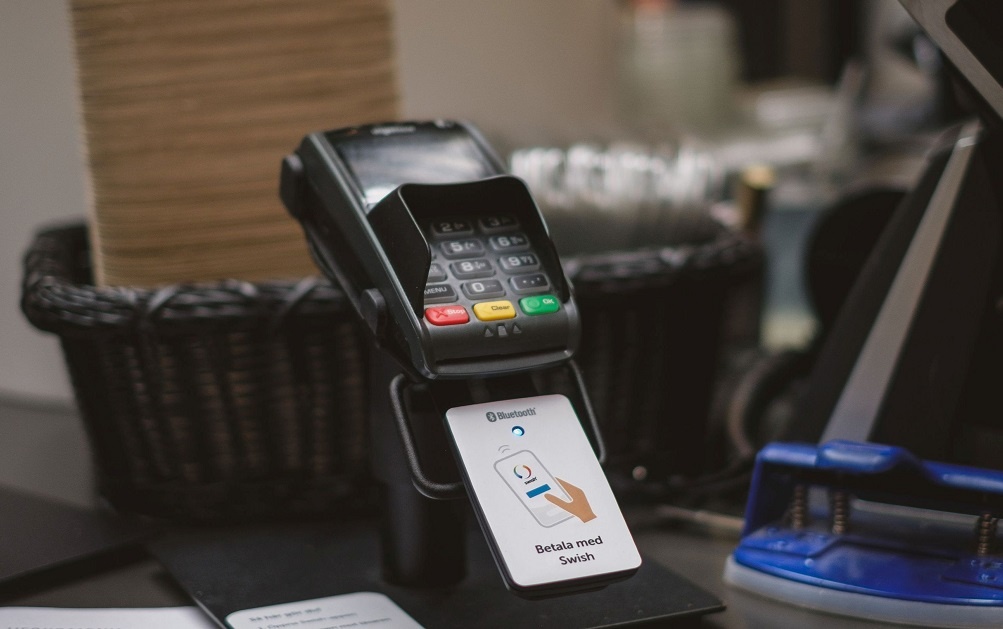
[71,0,397,287]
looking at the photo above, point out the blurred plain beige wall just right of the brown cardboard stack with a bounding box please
[394,0,617,144]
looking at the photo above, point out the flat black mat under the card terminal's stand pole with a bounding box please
[151,524,723,629]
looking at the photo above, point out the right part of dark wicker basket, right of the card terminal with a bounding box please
[551,233,764,491]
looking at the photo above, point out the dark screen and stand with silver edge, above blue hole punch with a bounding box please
[785,0,1003,469]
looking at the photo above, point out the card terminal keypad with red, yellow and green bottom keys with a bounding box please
[422,214,560,330]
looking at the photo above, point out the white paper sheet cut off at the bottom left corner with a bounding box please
[0,607,219,629]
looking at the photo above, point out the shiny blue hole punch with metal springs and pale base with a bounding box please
[725,441,1003,627]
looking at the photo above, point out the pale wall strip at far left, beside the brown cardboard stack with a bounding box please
[0,0,85,403]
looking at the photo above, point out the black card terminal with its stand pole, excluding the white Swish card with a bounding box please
[280,120,604,587]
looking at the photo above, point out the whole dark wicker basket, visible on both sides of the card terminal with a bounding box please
[22,226,762,521]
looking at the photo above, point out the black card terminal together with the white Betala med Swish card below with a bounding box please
[281,120,641,598]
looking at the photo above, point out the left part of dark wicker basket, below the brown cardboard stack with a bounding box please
[22,226,373,521]
